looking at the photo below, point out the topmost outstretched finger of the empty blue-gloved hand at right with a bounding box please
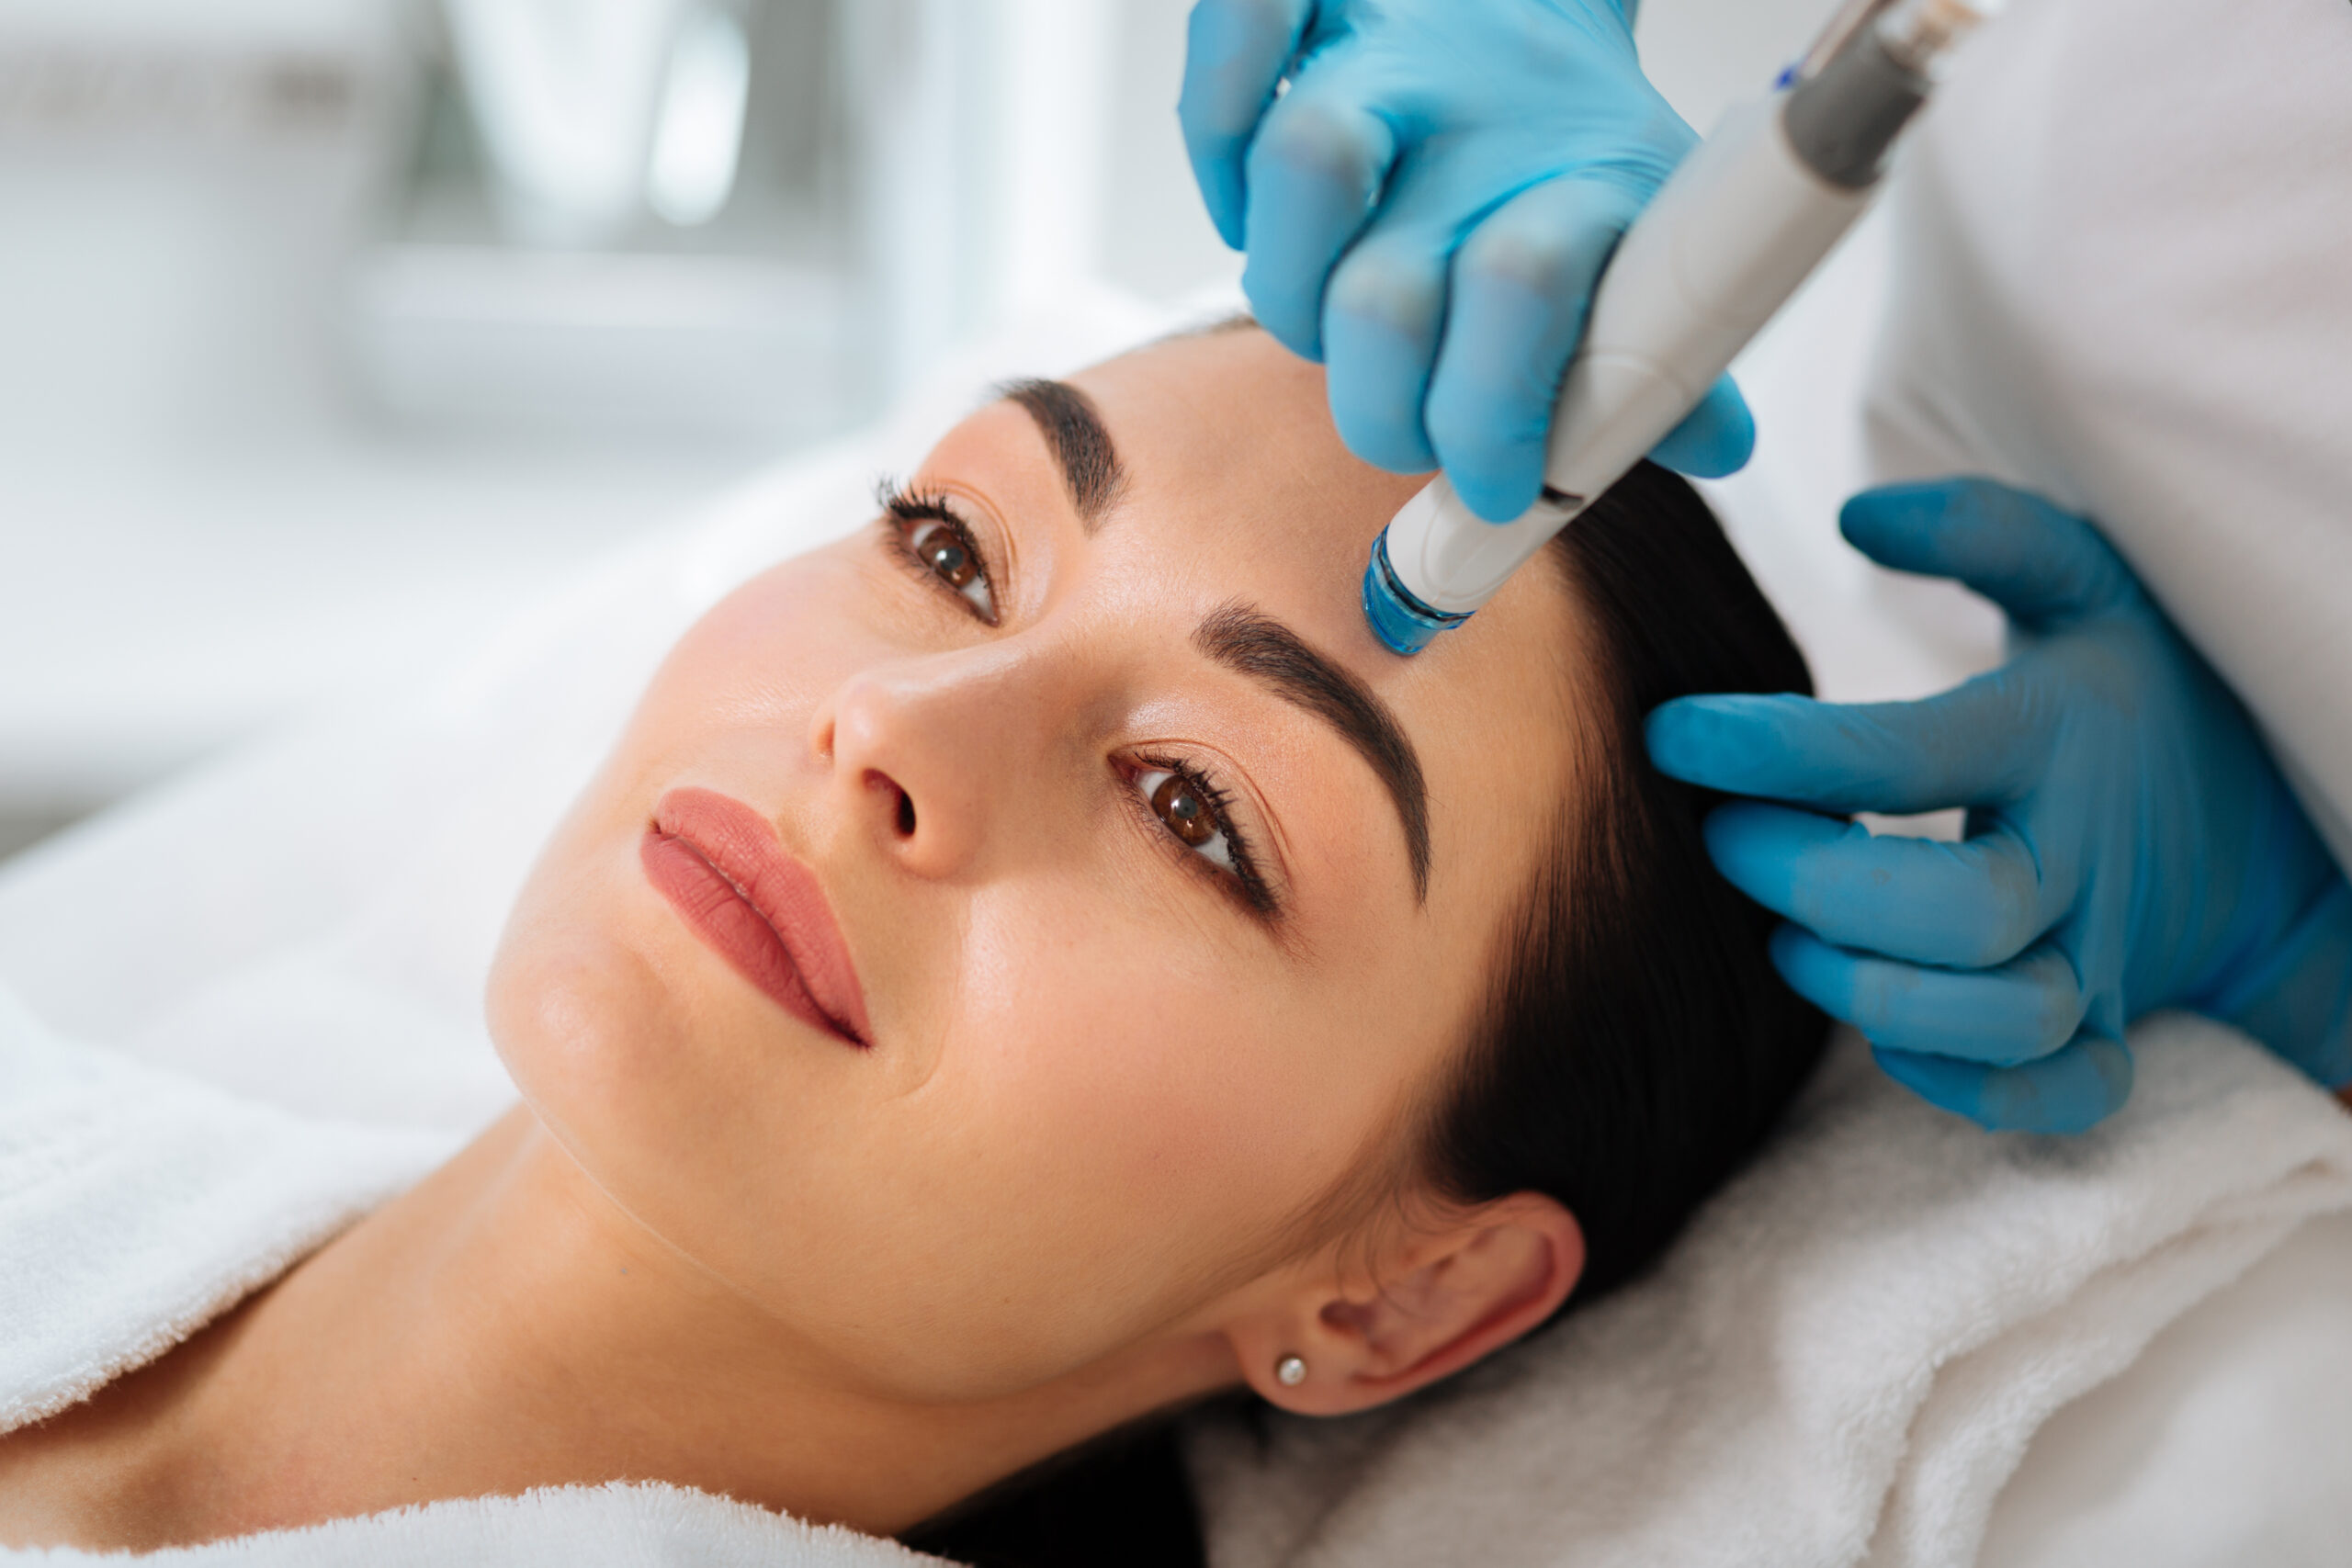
[1839,479,2141,627]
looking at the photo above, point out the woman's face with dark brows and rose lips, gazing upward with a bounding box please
[492,332,1574,1399]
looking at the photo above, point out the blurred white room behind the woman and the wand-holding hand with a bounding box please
[0,0,1827,858]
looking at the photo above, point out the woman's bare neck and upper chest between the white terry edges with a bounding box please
[0,1110,1235,1550]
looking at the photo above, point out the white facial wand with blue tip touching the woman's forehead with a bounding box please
[1364,0,1983,653]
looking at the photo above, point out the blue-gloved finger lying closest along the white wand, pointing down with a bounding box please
[1428,174,1642,522]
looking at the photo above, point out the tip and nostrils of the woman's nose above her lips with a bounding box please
[809,651,1045,879]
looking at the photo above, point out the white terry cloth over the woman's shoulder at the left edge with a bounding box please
[0,989,452,1432]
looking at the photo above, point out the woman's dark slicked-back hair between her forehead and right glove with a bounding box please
[1425,463,1827,1304]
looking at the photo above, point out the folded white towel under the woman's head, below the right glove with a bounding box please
[1190,1016,2352,1568]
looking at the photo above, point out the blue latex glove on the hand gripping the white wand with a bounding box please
[1179,0,1755,522]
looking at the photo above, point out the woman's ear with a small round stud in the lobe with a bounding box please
[1227,1192,1585,1416]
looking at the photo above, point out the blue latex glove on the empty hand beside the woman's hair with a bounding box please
[1649,479,2352,1131]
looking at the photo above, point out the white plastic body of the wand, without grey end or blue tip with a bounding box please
[1387,94,1872,616]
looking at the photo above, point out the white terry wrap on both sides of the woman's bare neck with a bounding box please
[0,989,938,1568]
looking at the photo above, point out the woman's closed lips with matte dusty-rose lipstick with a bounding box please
[638,787,873,1046]
